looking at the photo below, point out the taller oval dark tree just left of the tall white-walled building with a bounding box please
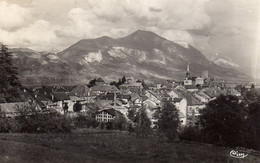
[158,103,180,140]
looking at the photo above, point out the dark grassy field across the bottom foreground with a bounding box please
[0,131,260,163]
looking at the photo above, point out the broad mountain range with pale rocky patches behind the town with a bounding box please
[11,30,250,84]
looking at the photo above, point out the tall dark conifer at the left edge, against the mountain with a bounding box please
[0,44,21,102]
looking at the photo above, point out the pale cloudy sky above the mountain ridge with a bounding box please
[0,0,260,77]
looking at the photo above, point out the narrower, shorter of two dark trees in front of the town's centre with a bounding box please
[134,108,151,138]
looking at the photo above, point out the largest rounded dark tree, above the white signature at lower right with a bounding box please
[199,95,246,146]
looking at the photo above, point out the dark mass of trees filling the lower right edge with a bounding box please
[180,90,260,149]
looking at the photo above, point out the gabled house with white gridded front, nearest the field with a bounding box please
[95,108,122,122]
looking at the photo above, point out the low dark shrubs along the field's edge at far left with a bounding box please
[0,105,72,133]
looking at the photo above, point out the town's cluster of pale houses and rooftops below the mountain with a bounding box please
[0,67,256,126]
